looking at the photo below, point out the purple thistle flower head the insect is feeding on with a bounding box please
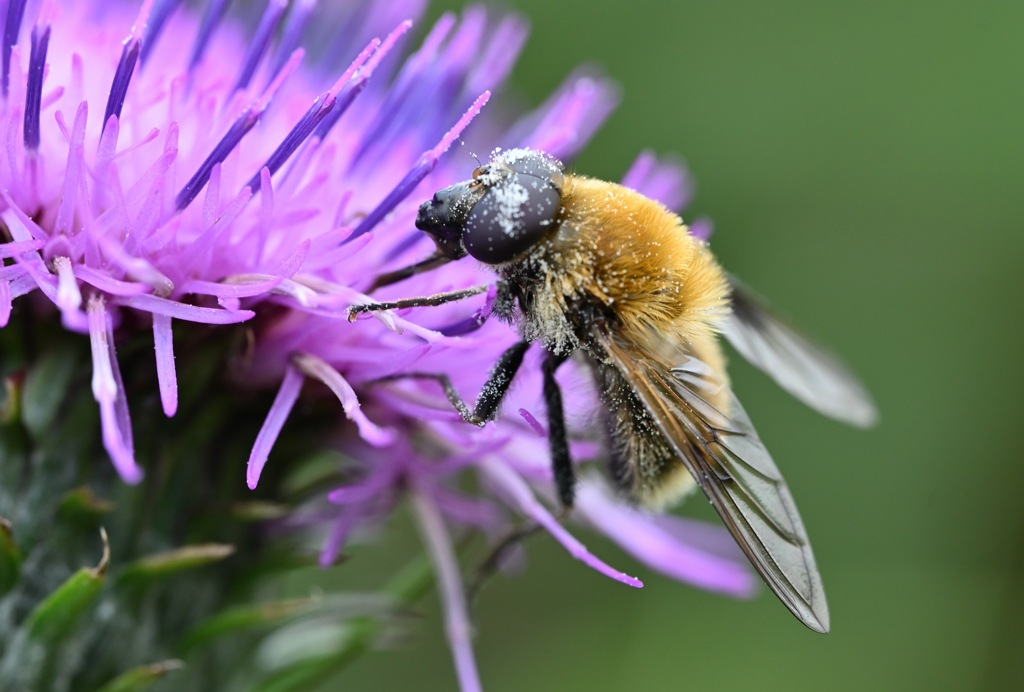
[0,0,754,690]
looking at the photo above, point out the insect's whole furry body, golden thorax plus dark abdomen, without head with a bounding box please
[498,176,729,508]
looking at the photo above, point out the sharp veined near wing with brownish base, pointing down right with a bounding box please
[597,334,828,632]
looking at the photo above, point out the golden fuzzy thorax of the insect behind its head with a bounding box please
[503,175,729,360]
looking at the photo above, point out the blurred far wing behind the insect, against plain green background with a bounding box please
[722,276,878,428]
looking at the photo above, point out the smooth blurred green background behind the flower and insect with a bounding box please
[323,0,1024,691]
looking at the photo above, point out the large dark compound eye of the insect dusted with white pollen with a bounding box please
[463,171,562,264]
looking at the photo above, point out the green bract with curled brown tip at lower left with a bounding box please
[27,528,111,647]
